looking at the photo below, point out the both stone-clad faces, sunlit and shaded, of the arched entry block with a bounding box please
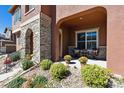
[20,13,51,62]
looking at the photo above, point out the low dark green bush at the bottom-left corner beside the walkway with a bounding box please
[7,77,26,88]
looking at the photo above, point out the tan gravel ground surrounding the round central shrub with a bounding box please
[20,64,83,88]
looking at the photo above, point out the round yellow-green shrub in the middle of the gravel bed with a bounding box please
[50,63,67,80]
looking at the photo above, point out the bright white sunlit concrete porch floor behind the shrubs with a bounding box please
[61,59,107,69]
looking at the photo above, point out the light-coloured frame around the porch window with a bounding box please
[75,27,99,49]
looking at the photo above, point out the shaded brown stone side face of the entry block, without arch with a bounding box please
[40,13,51,59]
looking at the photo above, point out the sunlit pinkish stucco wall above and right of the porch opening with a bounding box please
[56,5,124,75]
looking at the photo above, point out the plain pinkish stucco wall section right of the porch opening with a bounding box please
[106,6,124,75]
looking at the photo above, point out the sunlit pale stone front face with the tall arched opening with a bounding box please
[20,19,40,62]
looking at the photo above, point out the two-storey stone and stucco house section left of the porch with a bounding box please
[9,5,55,62]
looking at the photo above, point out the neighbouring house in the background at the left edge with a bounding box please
[0,27,16,54]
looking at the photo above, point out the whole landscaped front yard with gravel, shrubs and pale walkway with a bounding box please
[0,53,124,88]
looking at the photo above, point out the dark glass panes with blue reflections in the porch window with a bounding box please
[77,31,98,50]
